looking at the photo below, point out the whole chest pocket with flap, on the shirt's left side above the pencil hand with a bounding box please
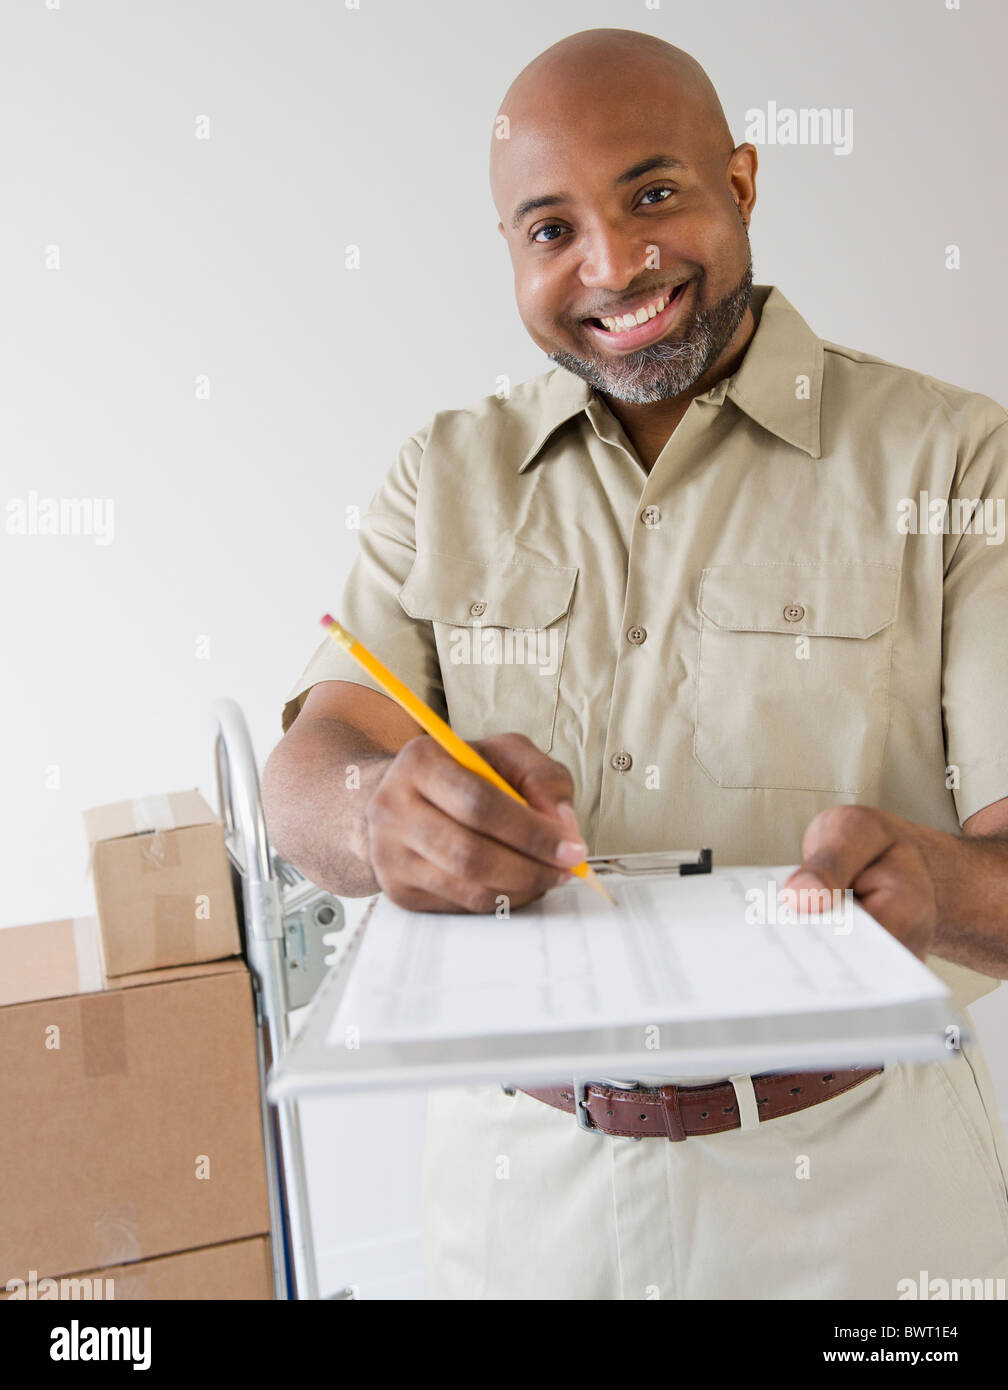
[399,552,577,752]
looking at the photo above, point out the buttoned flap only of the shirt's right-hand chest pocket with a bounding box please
[698,563,900,637]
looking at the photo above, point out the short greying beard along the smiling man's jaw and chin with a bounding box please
[549,231,752,406]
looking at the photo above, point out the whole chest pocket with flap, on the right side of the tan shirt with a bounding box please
[694,563,900,792]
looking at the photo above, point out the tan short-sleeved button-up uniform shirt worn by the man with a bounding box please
[282,285,1008,1023]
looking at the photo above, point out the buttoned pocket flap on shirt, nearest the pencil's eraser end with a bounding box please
[399,550,577,628]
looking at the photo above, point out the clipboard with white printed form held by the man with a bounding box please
[262,849,968,1101]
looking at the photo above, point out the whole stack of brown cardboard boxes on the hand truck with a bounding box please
[0,792,273,1300]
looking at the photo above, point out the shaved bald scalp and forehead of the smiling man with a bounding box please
[491,29,734,211]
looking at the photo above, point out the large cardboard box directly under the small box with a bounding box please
[0,917,270,1287]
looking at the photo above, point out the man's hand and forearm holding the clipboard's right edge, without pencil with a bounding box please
[784,798,1008,980]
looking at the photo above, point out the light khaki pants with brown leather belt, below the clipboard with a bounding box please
[423,1028,1008,1298]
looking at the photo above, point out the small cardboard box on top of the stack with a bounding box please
[83,788,241,976]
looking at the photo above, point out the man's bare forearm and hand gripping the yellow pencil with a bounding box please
[263,681,587,912]
